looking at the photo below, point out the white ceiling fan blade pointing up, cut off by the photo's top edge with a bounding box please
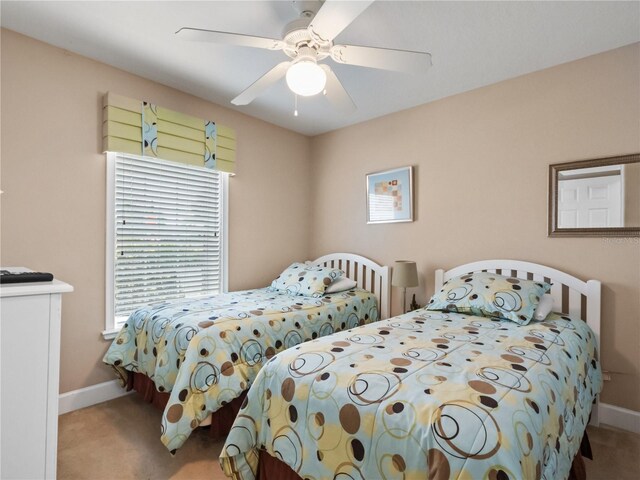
[309,0,373,43]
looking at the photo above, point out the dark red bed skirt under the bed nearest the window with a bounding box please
[127,372,245,438]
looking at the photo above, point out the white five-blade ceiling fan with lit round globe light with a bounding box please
[176,0,431,113]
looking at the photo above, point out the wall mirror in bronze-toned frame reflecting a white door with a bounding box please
[549,154,640,237]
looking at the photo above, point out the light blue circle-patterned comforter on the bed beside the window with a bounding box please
[103,288,378,451]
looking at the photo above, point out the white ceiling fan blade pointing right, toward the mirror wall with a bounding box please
[331,45,431,73]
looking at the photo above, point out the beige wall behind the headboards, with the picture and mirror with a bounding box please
[311,44,640,410]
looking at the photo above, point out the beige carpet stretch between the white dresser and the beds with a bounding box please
[58,394,227,480]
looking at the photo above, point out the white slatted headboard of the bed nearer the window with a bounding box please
[312,253,391,320]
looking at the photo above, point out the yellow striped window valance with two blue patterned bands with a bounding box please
[102,92,236,173]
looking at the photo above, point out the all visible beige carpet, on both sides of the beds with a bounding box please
[58,395,640,480]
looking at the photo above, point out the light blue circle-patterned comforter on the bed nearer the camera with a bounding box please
[220,310,602,480]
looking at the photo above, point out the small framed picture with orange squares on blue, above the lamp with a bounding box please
[367,166,413,223]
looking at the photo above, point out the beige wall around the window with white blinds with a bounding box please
[0,30,311,392]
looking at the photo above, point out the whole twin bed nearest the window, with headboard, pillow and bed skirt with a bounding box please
[104,253,390,452]
